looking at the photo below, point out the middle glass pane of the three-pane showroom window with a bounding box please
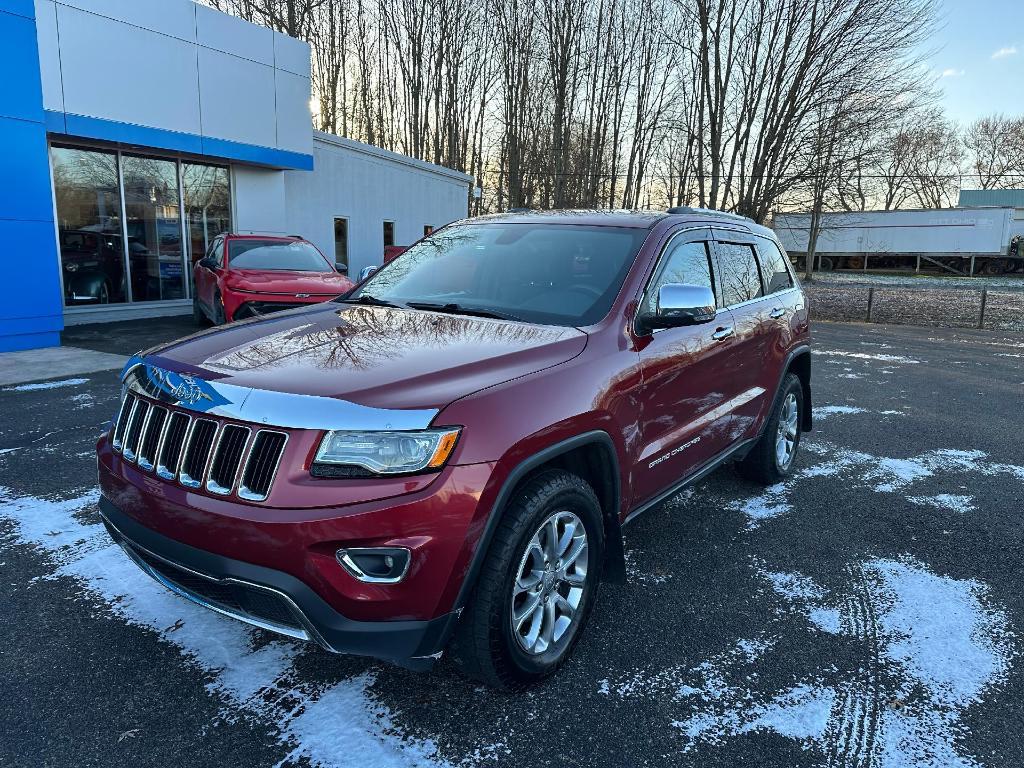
[121,155,185,301]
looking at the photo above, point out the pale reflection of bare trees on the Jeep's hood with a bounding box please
[207,306,577,371]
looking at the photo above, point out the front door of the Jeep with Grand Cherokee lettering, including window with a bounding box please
[634,228,731,502]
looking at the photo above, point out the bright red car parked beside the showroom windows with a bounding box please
[193,234,353,326]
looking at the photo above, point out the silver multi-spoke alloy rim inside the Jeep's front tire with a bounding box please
[509,510,589,655]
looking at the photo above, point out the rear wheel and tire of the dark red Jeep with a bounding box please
[736,374,804,485]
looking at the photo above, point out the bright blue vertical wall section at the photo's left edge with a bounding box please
[0,7,63,352]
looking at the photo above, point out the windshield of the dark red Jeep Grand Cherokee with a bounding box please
[348,223,647,326]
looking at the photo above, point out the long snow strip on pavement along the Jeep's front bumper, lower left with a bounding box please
[0,486,445,768]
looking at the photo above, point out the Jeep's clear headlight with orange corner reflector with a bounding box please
[313,428,459,476]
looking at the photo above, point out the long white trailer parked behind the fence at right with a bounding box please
[772,208,1024,274]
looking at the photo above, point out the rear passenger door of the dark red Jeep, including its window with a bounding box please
[715,228,788,441]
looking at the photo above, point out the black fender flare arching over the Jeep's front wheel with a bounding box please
[453,429,626,612]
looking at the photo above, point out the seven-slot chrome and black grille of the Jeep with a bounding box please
[112,392,288,502]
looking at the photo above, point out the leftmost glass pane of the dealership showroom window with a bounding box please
[53,146,128,306]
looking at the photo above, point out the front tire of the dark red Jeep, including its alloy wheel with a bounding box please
[455,470,604,690]
